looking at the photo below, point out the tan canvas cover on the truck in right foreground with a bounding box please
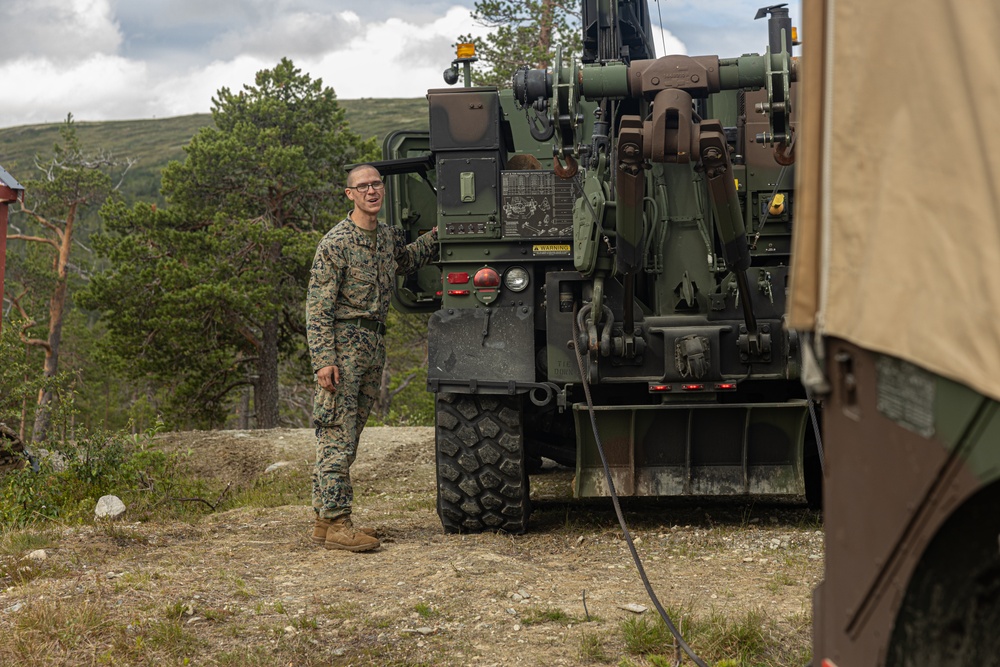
[789,0,1000,400]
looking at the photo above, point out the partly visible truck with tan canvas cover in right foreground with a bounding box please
[789,0,1000,667]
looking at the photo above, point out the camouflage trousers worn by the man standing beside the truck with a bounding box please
[313,325,385,519]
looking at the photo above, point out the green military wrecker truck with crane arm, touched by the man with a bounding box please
[379,0,819,533]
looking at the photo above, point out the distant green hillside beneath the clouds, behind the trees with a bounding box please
[0,98,427,201]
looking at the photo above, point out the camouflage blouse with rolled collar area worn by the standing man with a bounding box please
[306,217,438,371]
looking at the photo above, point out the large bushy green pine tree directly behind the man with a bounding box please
[82,59,376,428]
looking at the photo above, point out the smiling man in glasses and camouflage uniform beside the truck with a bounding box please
[306,165,438,551]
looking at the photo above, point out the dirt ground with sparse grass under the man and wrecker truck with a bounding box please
[0,428,823,667]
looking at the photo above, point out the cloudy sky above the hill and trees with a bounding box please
[0,0,800,127]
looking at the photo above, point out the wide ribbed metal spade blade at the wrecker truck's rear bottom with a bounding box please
[573,400,809,497]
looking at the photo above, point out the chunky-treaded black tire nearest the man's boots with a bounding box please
[435,394,531,533]
